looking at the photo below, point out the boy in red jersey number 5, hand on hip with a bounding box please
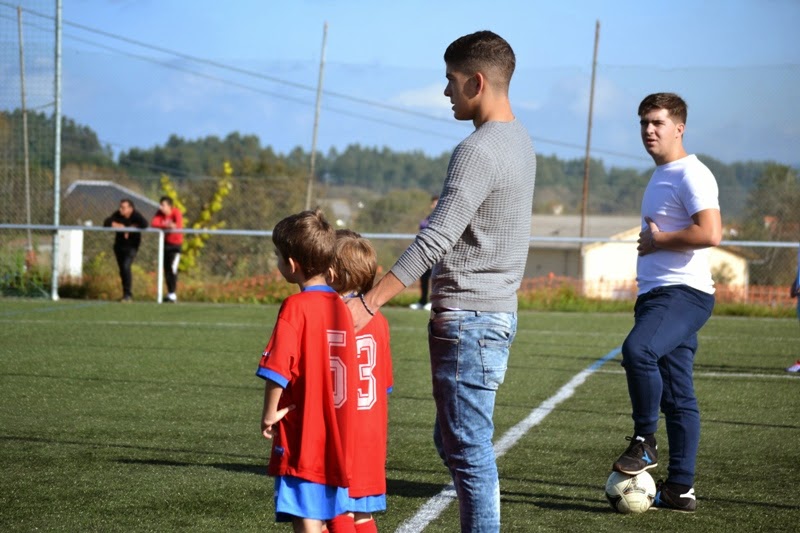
[256,210,356,532]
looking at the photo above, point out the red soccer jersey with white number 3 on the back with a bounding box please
[349,312,394,498]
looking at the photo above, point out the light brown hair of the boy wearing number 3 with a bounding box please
[330,229,378,294]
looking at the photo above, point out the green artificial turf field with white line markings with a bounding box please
[0,299,800,533]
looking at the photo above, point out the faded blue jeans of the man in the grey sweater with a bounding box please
[428,311,517,532]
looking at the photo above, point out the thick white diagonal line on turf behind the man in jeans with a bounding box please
[396,346,622,533]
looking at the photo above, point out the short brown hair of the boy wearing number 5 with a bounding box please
[272,209,336,278]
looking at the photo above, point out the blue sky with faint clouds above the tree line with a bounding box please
[0,0,800,167]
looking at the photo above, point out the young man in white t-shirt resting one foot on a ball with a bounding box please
[613,93,722,512]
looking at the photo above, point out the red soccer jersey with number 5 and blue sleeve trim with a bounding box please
[256,285,356,487]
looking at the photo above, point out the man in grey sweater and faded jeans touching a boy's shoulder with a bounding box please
[348,31,536,532]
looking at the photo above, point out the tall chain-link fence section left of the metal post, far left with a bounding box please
[0,0,56,277]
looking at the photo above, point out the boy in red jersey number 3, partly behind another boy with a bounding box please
[328,230,393,533]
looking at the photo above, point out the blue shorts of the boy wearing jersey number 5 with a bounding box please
[275,476,350,522]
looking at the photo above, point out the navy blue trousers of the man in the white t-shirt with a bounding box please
[622,285,714,486]
